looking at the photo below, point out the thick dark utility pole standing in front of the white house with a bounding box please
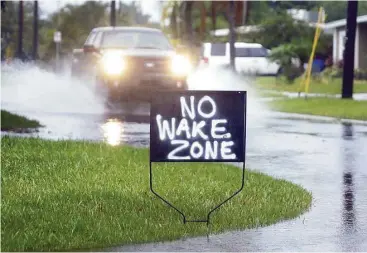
[342,0,358,98]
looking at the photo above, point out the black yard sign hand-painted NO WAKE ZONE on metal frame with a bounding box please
[150,91,246,223]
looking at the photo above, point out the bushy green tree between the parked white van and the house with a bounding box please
[250,10,332,81]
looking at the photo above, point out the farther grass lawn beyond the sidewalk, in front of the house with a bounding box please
[256,77,367,94]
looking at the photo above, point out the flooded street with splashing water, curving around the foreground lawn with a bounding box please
[1,62,367,251]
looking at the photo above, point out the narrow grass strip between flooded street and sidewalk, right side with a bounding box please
[268,98,367,120]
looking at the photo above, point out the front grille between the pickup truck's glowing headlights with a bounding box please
[127,57,170,75]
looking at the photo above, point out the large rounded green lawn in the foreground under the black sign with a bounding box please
[1,136,312,251]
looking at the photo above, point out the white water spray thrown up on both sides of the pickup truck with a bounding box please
[1,63,268,136]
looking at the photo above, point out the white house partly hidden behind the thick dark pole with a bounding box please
[323,15,367,69]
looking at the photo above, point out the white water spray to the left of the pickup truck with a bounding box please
[1,62,104,114]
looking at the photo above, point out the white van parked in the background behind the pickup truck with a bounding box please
[199,42,280,75]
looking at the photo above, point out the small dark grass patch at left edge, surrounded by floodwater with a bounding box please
[1,110,41,131]
